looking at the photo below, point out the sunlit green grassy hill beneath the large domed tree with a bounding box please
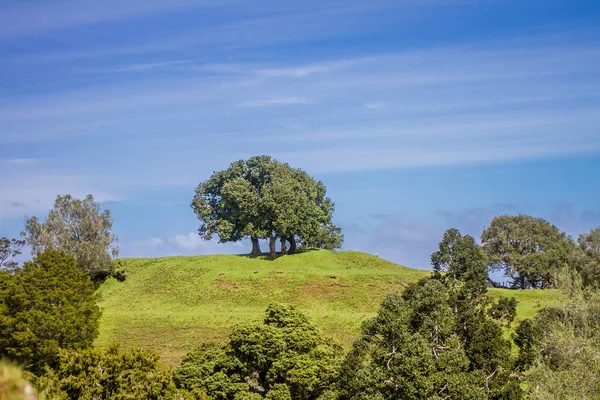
[96,250,558,364]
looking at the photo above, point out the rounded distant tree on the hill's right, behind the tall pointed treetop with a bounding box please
[481,215,575,289]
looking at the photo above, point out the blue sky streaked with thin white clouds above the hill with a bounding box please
[0,0,600,268]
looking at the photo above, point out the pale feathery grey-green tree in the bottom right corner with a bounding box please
[515,290,600,399]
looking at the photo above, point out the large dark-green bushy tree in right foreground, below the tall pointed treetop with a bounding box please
[340,279,521,399]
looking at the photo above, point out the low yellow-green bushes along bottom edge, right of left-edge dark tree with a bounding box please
[36,346,194,400]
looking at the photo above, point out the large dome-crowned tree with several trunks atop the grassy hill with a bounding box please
[191,156,339,256]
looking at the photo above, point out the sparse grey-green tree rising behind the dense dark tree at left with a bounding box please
[22,194,119,281]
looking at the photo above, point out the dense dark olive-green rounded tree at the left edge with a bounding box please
[0,250,100,372]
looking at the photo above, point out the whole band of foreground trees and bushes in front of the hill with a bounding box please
[0,223,600,400]
